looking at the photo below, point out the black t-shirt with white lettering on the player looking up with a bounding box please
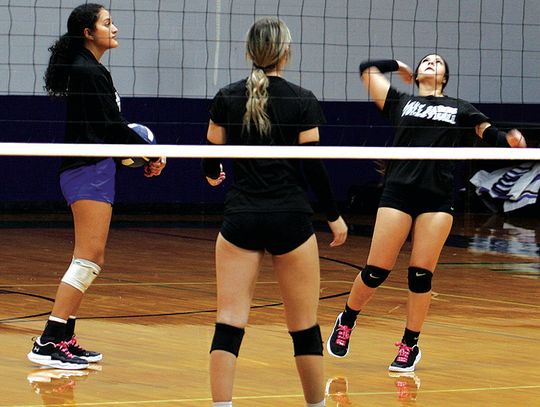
[382,87,490,197]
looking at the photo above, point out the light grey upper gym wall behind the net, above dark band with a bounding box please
[4,0,540,103]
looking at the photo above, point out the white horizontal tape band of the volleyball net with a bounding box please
[0,143,540,160]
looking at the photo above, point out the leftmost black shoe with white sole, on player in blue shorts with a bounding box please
[28,337,88,370]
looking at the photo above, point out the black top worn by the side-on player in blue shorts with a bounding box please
[60,48,144,171]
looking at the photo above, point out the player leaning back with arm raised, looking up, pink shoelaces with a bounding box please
[327,54,526,372]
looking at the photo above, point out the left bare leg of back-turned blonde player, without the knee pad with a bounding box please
[210,234,264,402]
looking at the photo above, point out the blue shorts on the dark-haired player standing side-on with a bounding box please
[60,158,116,205]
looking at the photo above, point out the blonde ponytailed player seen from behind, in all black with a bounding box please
[203,18,347,406]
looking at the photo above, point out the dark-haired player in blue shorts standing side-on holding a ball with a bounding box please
[28,3,165,369]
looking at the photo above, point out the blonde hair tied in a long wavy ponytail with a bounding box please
[243,17,291,136]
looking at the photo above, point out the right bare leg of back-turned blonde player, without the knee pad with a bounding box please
[272,235,324,403]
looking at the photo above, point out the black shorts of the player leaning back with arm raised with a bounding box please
[379,185,454,219]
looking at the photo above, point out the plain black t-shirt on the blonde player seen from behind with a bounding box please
[210,76,325,217]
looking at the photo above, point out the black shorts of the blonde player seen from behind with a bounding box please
[221,212,314,255]
